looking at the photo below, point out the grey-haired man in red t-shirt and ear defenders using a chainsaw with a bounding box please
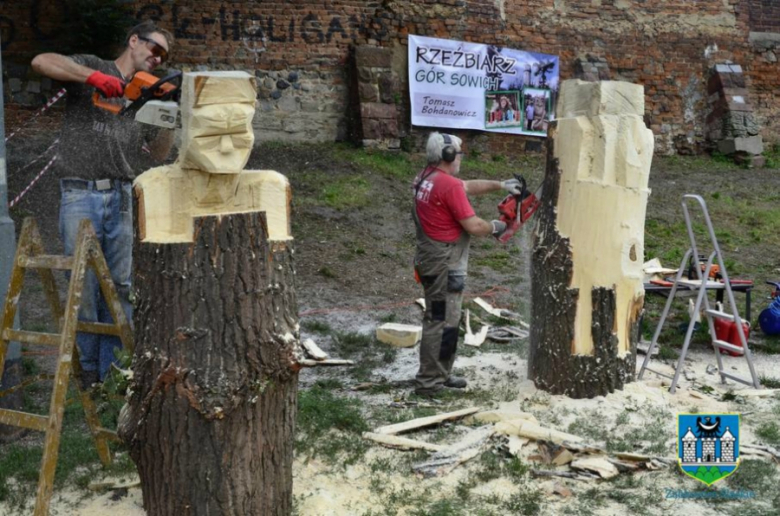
[412,132,520,396]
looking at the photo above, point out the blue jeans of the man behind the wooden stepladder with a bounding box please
[60,178,133,381]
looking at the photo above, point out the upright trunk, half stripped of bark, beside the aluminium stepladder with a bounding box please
[528,80,653,398]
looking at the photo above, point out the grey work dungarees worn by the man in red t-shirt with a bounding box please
[414,214,469,393]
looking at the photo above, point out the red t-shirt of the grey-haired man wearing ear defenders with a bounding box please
[414,168,475,242]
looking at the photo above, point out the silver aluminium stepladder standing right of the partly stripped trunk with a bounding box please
[638,194,761,394]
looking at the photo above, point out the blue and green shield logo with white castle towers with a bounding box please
[677,414,740,486]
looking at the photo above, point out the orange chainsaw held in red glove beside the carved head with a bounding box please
[92,71,182,129]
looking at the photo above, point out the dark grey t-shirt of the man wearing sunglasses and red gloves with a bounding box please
[57,55,158,180]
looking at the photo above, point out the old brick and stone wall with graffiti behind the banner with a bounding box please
[0,0,780,153]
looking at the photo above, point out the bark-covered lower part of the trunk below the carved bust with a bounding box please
[120,212,300,516]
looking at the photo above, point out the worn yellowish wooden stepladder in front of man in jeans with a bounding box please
[0,218,133,516]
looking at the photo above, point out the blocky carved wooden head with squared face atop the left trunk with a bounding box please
[179,72,257,174]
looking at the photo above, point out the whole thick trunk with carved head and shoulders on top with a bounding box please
[119,72,303,516]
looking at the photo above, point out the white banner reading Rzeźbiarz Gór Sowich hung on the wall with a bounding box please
[409,35,559,136]
